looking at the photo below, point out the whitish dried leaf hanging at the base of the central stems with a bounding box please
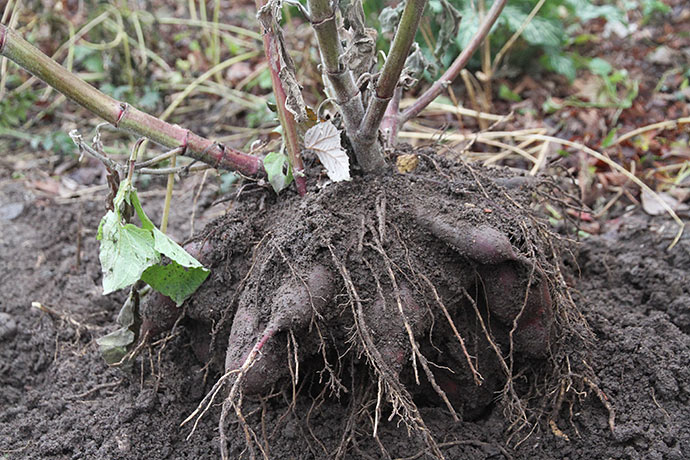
[304,121,350,182]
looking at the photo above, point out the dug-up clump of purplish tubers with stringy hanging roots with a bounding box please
[176,160,592,460]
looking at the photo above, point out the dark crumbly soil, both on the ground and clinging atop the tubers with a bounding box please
[0,156,690,459]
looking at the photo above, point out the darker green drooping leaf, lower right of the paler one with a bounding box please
[141,262,209,307]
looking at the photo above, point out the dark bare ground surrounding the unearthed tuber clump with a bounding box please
[0,156,690,459]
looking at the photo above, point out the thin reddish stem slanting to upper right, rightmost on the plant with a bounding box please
[400,0,507,125]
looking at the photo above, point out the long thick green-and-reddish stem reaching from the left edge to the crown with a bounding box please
[0,24,264,176]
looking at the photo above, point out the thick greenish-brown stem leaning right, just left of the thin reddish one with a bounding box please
[358,0,426,151]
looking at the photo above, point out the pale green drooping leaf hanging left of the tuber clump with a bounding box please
[98,211,160,294]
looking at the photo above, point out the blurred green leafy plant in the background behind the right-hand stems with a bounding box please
[364,0,628,81]
